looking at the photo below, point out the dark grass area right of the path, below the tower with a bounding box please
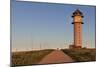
[62,49,96,62]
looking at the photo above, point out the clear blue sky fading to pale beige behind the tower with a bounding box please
[11,0,96,50]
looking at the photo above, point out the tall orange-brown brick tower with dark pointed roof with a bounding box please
[72,9,84,48]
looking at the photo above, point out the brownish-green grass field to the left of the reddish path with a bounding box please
[12,49,53,66]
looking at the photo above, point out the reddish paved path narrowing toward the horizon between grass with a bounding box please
[39,50,74,64]
